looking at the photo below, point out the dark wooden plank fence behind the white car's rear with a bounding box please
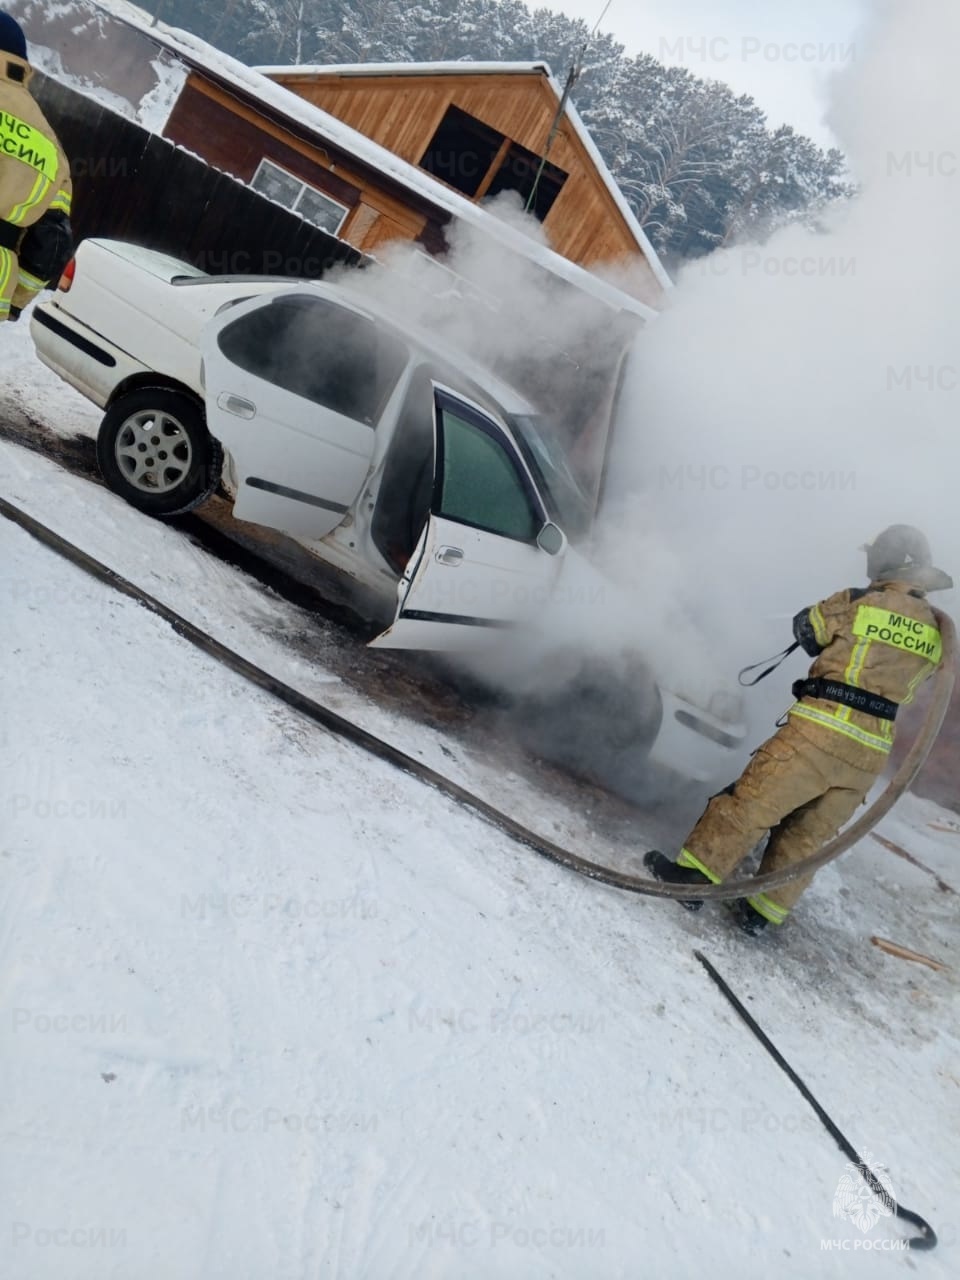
[31,72,361,276]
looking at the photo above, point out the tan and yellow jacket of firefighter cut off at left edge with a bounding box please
[0,52,72,320]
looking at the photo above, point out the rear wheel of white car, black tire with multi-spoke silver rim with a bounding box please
[97,387,223,517]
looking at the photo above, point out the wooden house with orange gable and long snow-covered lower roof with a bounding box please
[6,0,671,319]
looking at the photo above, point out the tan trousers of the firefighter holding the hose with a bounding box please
[677,721,887,924]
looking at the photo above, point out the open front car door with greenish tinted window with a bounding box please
[371,387,566,652]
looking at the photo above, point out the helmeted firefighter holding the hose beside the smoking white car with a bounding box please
[644,525,952,933]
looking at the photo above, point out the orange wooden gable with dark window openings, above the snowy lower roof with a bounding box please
[248,63,668,302]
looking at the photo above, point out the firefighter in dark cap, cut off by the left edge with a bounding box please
[0,10,73,323]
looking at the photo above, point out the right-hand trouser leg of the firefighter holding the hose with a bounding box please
[748,765,874,924]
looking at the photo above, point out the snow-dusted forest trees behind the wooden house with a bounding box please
[154,0,852,265]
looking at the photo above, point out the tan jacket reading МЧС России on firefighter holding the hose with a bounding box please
[788,581,942,772]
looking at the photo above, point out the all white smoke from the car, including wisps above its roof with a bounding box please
[335,0,960,773]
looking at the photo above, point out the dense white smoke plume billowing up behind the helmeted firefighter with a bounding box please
[603,0,960,721]
